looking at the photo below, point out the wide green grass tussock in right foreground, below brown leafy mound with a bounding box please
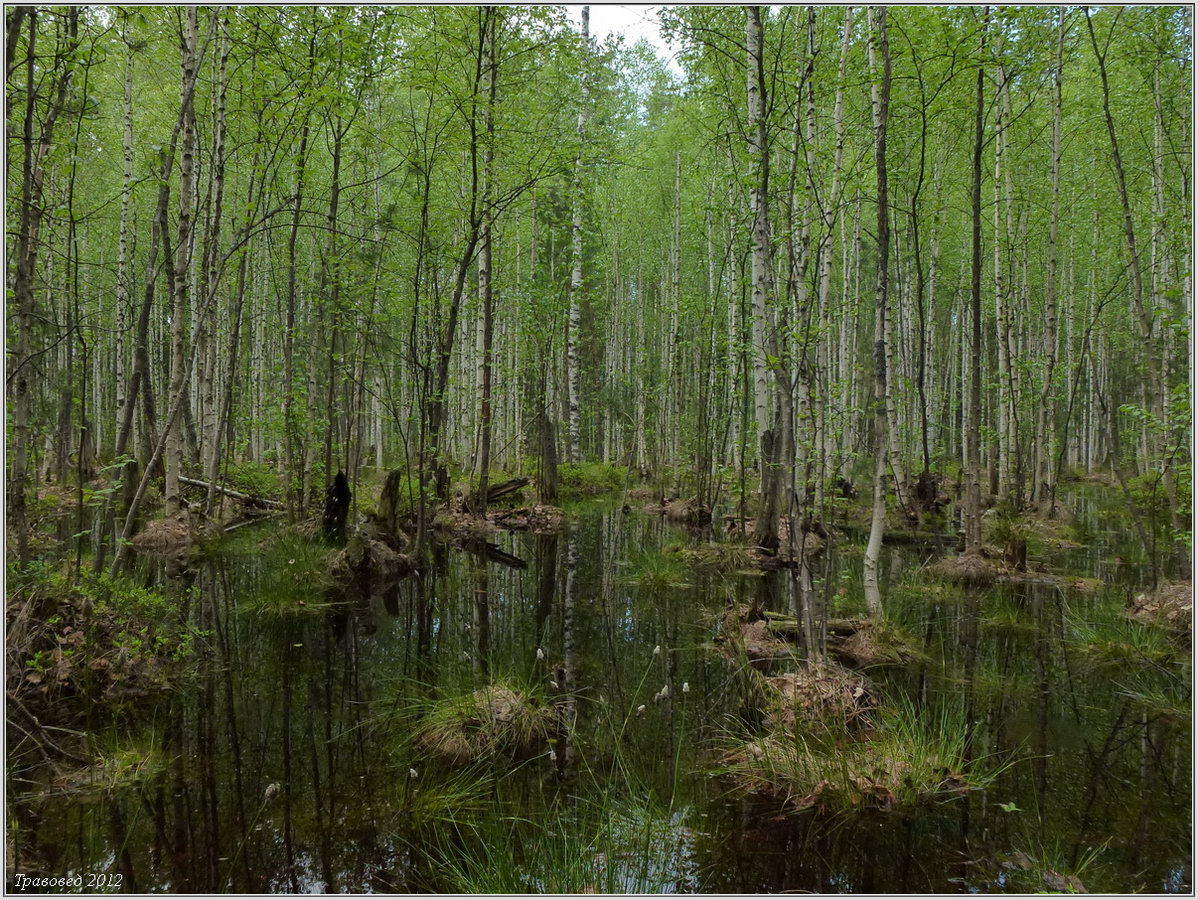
[722,699,1004,814]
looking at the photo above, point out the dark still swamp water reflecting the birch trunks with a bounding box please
[8,491,1192,893]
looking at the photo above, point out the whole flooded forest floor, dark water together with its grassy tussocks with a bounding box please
[6,474,1192,893]
